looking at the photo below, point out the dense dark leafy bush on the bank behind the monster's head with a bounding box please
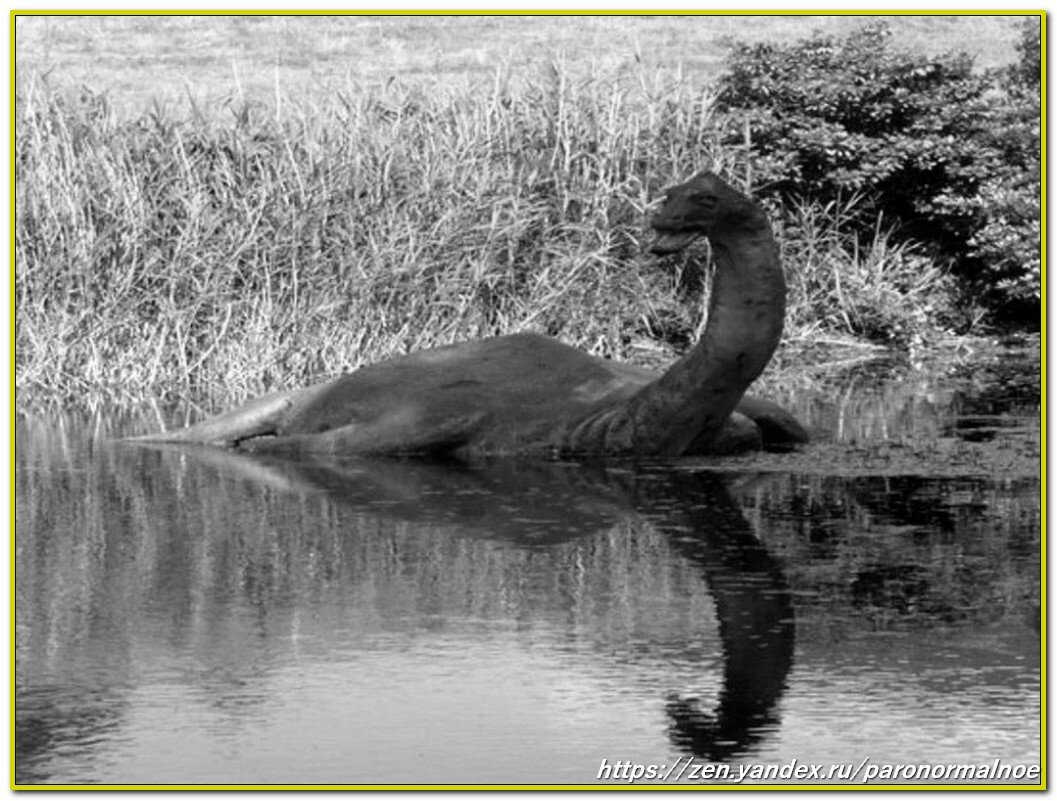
[718,20,1040,324]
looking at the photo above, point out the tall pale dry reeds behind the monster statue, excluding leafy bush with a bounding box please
[15,61,947,408]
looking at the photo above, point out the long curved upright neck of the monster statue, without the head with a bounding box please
[606,222,785,455]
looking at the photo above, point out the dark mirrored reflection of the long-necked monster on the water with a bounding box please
[208,451,795,761]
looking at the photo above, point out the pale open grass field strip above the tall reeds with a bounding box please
[16,16,1016,113]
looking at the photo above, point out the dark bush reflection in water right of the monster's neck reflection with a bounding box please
[736,473,1041,637]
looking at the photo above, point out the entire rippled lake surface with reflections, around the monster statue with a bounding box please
[16,351,1041,784]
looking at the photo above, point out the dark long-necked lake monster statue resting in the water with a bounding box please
[138,171,808,460]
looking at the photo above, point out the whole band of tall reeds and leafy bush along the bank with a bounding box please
[14,18,1041,408]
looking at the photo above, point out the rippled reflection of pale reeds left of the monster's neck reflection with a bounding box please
[17,422,720,693]
